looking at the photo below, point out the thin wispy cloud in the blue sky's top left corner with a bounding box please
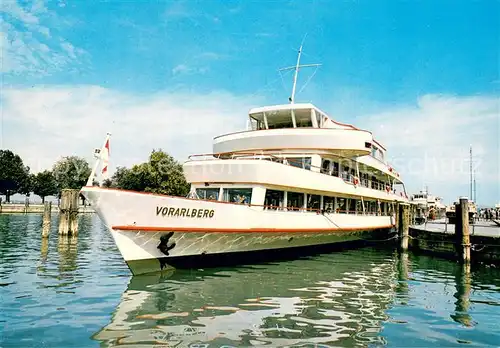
[0,0,87,75]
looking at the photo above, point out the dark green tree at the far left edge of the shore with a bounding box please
[0,150,30,202]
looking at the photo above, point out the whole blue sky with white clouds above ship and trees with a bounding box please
[0,0,500,205]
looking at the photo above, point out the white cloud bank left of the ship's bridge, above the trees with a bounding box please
[0,86,260,172]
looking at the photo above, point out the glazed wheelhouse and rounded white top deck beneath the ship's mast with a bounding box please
[213,103,374,158]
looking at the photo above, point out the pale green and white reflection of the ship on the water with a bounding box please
[93,250,397,347]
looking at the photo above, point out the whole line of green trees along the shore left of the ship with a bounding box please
[0,150,189,202]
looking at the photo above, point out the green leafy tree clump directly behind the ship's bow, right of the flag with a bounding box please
[106,150,189,196]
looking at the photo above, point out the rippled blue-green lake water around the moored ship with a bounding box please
[0,215,500,348]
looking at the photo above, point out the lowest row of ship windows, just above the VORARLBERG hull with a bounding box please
[196,188,391,215]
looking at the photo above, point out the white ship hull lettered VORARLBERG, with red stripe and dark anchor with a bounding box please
[82,187,394,274]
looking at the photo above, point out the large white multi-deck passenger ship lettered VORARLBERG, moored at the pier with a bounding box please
[82,47,408,274]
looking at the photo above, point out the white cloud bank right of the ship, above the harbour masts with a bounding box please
[357,95,500,204]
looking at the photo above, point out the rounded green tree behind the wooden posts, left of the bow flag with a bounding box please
[52,156,91,194]
